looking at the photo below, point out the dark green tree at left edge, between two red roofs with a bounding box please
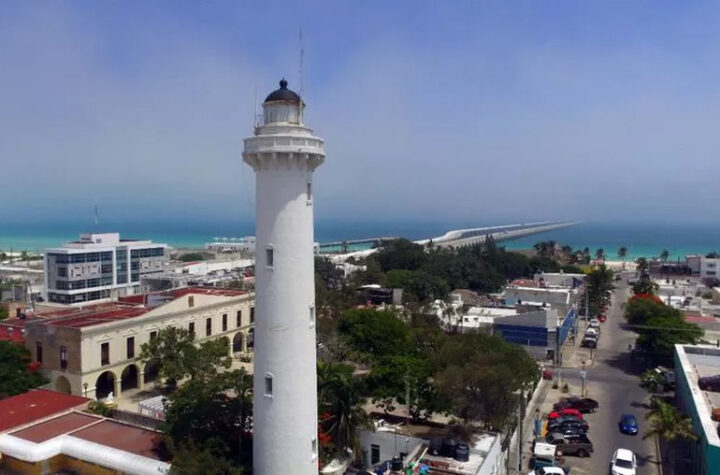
[0,341,48,399]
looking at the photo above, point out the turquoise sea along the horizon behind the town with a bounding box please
[0,220,720,258]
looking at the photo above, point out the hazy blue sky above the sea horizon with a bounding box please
[0,0,720,225]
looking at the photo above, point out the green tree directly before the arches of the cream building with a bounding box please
[139,327,231,393]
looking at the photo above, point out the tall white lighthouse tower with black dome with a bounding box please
[243,79,325,475]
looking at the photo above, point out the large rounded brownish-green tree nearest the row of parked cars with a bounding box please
[435,333,538,430]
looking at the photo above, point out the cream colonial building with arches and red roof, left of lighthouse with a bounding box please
[24,287,254,398]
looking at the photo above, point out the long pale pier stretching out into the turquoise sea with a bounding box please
[330,221,577,262]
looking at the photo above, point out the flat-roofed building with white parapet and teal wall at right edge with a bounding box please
[675,345,720,475]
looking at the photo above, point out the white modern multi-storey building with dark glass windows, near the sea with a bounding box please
[44,233,167,304]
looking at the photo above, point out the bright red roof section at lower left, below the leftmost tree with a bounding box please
[0,389,90,432]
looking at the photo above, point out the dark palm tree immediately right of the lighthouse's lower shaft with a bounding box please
[317,361,370,460]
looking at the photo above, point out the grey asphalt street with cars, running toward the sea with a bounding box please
[563,281,659,475]
